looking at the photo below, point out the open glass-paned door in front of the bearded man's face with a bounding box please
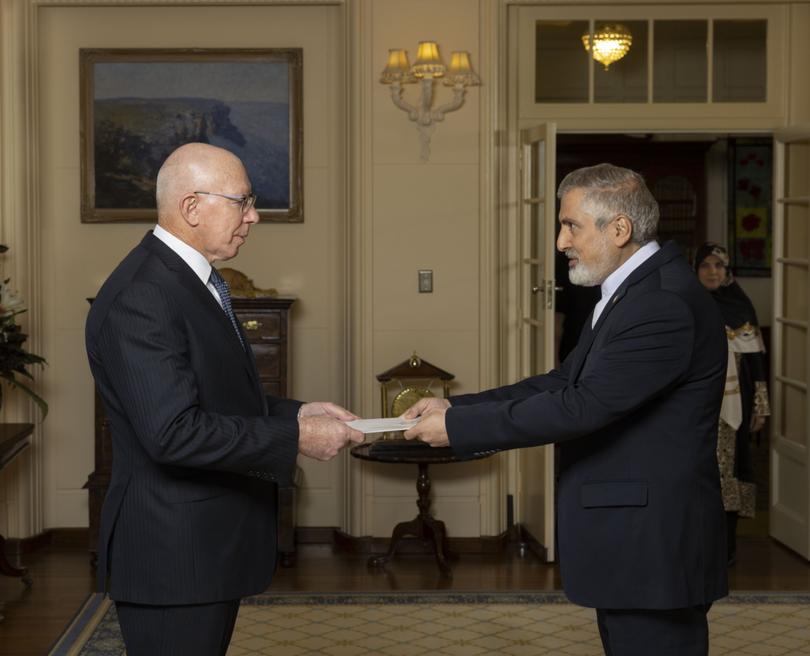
[517,123,556,560]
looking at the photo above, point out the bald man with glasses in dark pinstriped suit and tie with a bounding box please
[86,144,362,656]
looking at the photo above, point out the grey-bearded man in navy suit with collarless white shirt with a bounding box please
[404,164,728,656]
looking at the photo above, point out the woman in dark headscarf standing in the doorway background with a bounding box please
[695,242,771,565]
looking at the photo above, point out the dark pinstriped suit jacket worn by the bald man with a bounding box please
[86,232,300,605]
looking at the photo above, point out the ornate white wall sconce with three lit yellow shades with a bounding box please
[380,41,481,162]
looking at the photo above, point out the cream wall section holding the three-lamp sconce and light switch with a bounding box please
[356,0,497,537]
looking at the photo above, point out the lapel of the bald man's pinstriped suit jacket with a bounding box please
[141,232,265,407]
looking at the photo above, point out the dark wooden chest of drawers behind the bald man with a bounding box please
[84,296,295,566]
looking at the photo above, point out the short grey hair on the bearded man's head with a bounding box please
[557,164,659,245]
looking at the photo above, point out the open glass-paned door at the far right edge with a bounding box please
[770,126,810,559]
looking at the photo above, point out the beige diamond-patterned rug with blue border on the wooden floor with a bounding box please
[50,592,810,656]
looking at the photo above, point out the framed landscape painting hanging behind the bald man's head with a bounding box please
[79,48,303,223]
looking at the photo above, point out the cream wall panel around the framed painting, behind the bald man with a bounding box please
[38,6,346,527]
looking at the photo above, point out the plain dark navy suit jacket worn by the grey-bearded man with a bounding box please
[446,242,727,609]
